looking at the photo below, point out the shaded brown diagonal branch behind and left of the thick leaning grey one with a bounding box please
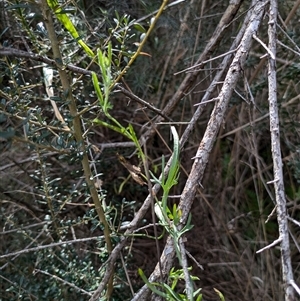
[141,0,243,142]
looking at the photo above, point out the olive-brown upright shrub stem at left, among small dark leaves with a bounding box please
[36,0,113,298]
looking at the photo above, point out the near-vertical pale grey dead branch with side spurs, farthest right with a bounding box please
[268,0,295,301]
